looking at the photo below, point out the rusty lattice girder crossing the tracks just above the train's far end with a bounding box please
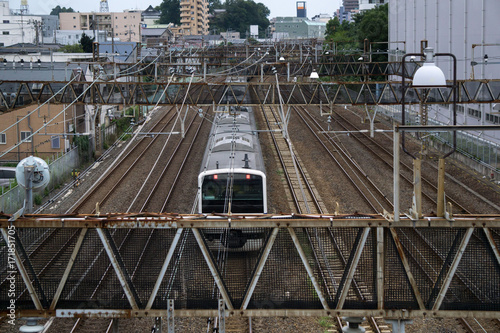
[0,80,500,112]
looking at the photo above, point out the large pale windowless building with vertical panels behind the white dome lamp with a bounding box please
[389,0,500,143]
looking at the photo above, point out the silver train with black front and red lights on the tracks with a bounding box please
[198,106,267,213]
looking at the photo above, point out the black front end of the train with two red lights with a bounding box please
[201,173,264,213]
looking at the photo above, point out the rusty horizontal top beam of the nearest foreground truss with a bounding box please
[0,213,500,229]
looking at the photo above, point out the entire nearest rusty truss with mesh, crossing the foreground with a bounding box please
[0,214,500,319]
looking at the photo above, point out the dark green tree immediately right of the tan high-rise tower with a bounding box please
[210,0,271,36]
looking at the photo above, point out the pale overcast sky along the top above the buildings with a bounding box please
[9,0,342,19]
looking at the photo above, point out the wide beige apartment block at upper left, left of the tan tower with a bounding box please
[59,10,142,42]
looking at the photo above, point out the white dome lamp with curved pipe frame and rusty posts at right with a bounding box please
[394,47,457,220]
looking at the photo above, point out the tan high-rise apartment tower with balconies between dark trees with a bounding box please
[179,0,208,35]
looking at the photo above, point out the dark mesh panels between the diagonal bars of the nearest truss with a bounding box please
[0,228,500,311]
